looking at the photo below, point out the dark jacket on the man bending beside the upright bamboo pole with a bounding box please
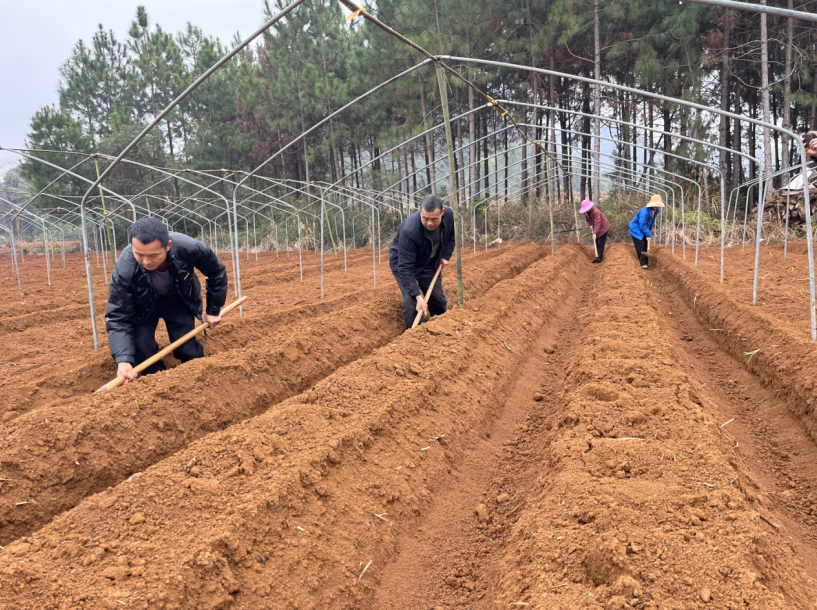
[389,206,454,297]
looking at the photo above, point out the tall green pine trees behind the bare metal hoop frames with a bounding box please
[17,0,817,223]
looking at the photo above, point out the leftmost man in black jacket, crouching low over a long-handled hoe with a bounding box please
[105,218,227,382]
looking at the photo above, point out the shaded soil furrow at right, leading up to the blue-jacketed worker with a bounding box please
[650,258,817,579]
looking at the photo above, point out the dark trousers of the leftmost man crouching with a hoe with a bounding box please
[133,294,204,375]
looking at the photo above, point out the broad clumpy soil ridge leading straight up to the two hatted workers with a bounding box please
[484,245,814,610]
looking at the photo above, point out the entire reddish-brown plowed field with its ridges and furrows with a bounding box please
[0,244,817,610]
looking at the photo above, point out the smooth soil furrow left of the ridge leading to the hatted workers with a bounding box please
[367,246,598,610]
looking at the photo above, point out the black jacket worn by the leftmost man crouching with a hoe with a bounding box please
[105,233,227,364]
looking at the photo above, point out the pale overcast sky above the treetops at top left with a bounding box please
[0,0,274,174]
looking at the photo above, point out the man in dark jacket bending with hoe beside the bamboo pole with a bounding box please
[389,195,454,328]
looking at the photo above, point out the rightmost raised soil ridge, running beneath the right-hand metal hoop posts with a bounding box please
[658,250,817,441]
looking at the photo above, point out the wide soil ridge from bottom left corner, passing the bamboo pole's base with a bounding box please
[0,246,590,610]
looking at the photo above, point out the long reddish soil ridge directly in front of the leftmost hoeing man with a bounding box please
[0,246,547,544]
